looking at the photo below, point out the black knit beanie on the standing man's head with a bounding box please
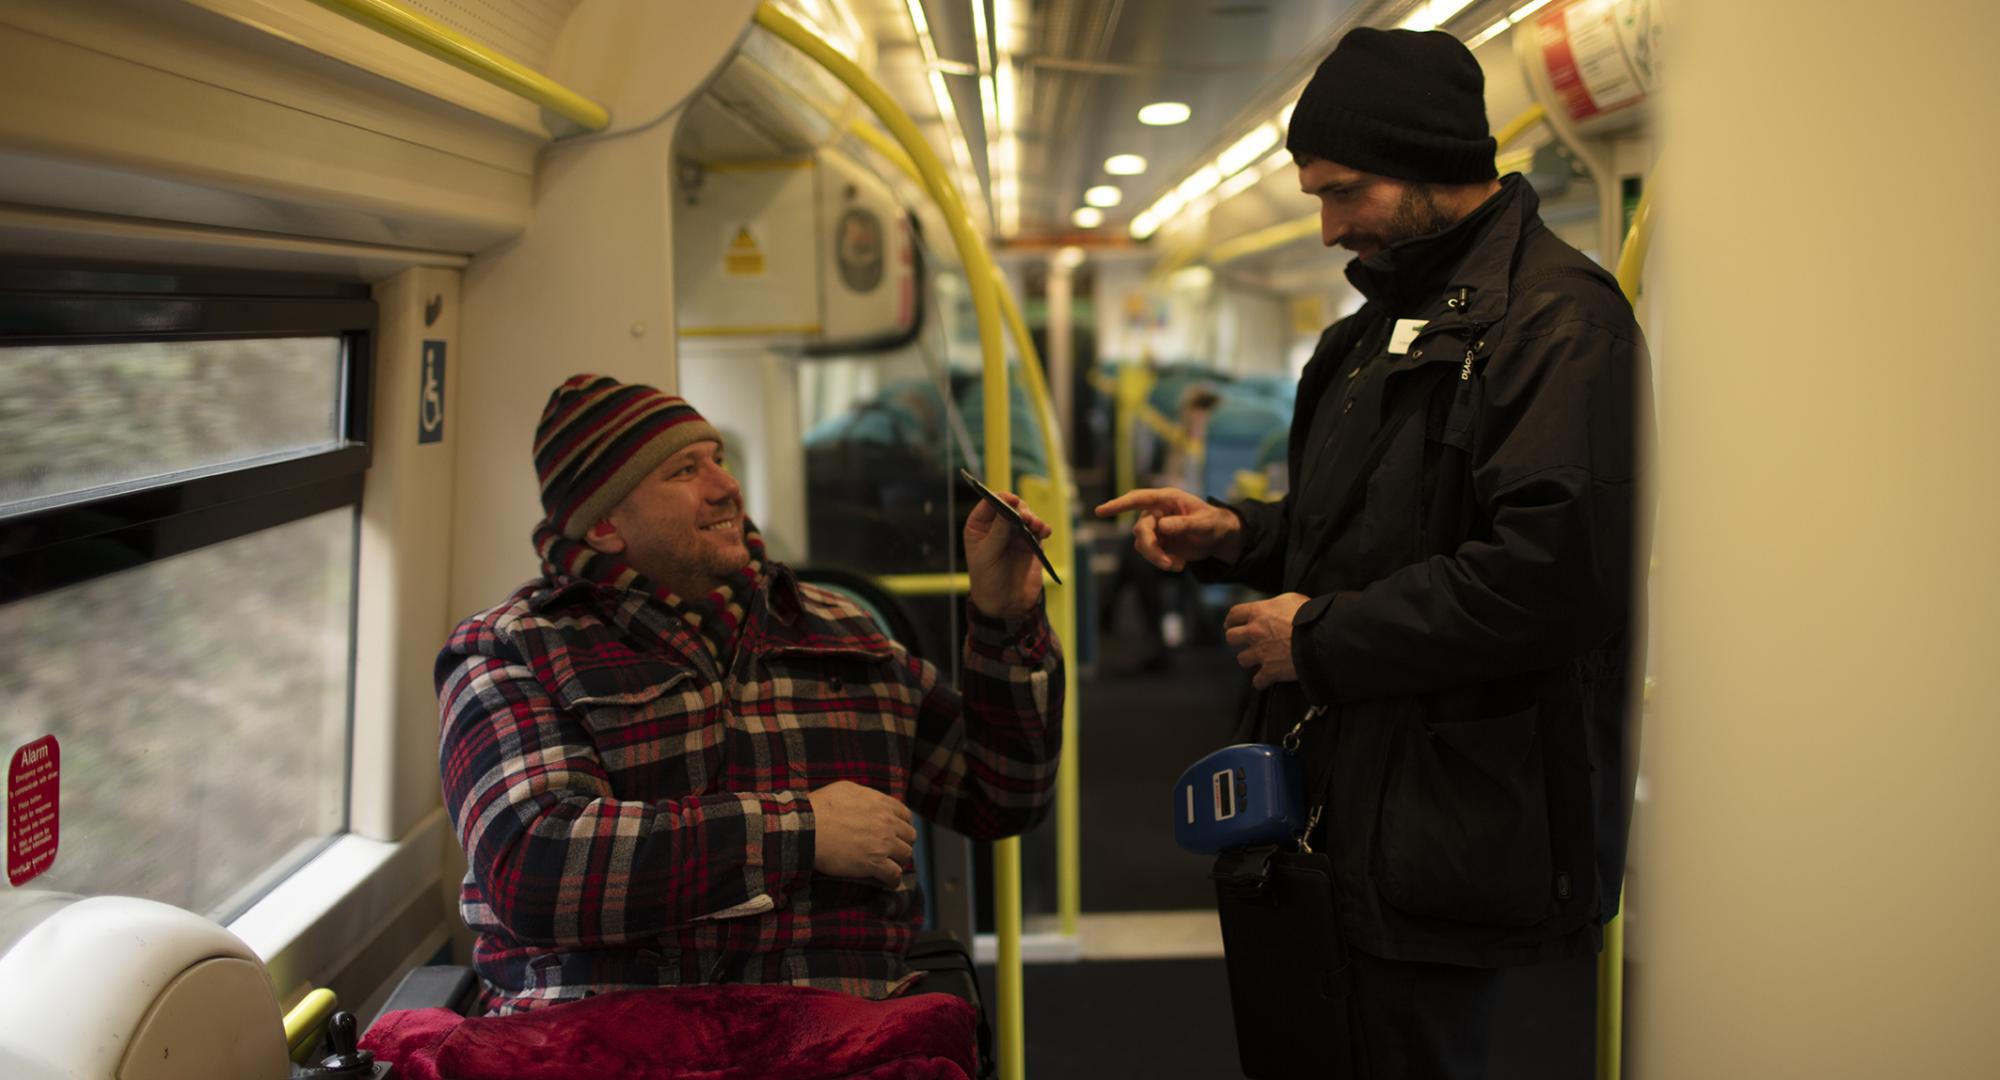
[1284,26,1496,184]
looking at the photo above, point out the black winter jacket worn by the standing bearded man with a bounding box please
[1196,176,1652,966]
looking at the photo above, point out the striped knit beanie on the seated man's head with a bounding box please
[534,374,722,540]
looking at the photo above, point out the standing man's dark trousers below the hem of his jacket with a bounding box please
[1348,952,1502,1080]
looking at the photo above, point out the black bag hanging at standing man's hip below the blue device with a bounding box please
[1208,708,1352,1080]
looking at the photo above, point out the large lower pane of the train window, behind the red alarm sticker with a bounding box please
[0,510,354,918]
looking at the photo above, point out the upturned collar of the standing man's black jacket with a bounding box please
[1348,174,1542,328]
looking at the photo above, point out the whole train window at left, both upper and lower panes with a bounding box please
[0,268,376,920]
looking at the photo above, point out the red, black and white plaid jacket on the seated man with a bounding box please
[436,548,1062,1012]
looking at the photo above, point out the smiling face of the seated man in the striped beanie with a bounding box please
[584,440,750,600]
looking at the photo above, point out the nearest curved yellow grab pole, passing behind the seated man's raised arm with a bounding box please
[756,10,1028,1080]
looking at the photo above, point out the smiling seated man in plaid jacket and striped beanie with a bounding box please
[436,376,1062,1014]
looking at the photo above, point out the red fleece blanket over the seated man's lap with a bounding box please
[362,986,978,1080]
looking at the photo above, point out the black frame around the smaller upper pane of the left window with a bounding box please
[0,266,378,604]
